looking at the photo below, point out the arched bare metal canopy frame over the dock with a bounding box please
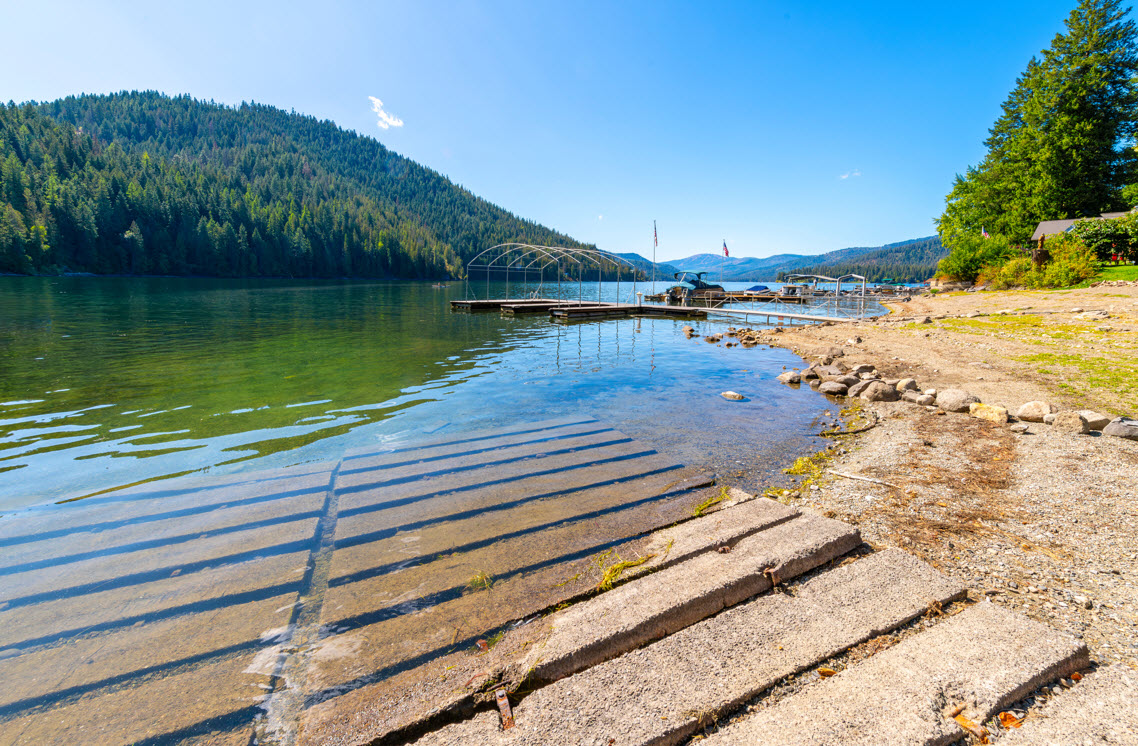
[467,242,638,302]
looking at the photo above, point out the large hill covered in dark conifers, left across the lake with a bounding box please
[0,92,596,277]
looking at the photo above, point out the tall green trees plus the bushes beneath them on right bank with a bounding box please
[937,0,1138,288]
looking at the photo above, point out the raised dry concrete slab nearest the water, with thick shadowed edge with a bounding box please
[525,514,861,683]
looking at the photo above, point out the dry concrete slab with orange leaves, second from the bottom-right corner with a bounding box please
[704,603,1089,746]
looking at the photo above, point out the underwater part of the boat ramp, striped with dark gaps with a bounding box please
[0,418,708,744]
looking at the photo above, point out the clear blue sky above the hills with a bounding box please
[0,0,1074,260]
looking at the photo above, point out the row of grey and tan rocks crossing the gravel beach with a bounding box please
[778,347,1138,440]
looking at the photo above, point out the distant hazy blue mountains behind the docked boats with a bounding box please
[671,235,947,282]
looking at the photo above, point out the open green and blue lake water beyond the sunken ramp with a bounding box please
[0,277,828,512]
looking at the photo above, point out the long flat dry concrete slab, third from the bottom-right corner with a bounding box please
[417,549,964,746]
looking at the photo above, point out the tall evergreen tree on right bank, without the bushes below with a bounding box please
[938,0,1138,249]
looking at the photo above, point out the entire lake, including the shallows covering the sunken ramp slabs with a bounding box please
[0,277,855,744]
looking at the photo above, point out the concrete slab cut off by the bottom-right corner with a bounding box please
[1000,663,1138,746]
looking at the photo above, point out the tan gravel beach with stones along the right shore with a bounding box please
[728,285,1138,668]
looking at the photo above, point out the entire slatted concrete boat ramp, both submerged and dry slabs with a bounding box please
[0,418,1138,746]
